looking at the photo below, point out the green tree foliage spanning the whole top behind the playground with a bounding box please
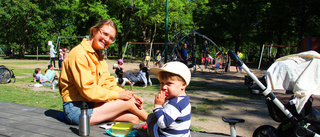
[0,0,320,60]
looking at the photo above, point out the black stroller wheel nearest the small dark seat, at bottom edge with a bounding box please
[252,125,276,137]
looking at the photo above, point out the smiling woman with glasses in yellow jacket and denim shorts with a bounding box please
[59,19,148,125]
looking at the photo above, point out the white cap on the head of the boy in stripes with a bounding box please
[150,61,191,85]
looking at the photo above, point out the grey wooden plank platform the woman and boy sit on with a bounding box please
[0,101,229,137]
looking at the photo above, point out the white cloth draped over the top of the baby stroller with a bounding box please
[265,51,320,113]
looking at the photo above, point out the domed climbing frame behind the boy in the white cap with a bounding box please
[162,29,229,72]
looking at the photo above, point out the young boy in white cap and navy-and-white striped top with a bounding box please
[147,61,191,137]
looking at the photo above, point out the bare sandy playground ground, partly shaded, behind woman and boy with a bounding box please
[0,60,277,137]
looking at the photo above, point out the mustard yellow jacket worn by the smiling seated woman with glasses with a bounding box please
[59,39,124,102]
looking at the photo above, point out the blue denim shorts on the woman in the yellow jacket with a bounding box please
[63,101,94,125]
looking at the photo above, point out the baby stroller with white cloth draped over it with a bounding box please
[229,51,320,137]
